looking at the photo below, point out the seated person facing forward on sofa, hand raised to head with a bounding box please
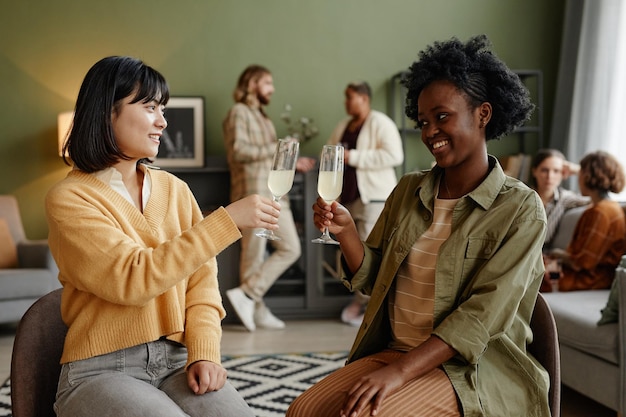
[530,149,591,250]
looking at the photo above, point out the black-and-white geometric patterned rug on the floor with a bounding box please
[0,352,347,417]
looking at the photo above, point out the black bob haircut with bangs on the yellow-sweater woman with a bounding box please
[63,56,170,172]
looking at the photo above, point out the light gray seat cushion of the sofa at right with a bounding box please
[543,290,619,365]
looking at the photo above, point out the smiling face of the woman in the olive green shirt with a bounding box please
[418,80,491,169]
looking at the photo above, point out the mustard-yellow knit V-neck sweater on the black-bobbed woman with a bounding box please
[46,166,241,366]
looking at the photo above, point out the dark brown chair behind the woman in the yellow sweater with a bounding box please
[11,289,67,417]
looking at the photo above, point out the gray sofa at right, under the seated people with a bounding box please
[544,202,626,415]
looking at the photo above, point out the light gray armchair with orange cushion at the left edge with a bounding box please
[0,195,61,323]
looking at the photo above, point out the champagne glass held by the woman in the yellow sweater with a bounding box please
[256,138,300,240]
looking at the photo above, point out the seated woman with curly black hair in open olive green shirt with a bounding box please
[287,36,550,417]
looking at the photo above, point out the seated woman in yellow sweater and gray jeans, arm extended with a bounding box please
[46,56,280,417]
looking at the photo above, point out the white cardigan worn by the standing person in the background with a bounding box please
[328,110,404,204]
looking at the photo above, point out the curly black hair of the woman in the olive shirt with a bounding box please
[402,35,535,140]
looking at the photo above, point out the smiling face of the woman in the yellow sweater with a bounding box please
[111,95,167,161]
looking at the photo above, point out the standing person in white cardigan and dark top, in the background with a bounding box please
[328,82,404,326]
